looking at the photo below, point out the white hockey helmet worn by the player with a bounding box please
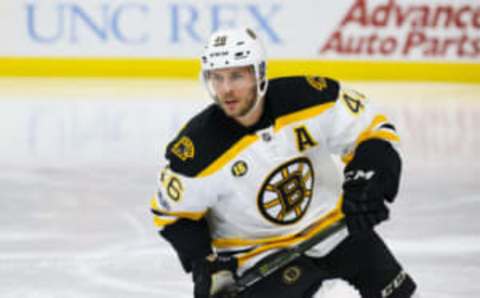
[201,28,268,115]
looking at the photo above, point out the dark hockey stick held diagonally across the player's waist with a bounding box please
[212,218,346,298]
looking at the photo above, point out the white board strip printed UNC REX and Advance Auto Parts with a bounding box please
[0,0,480,61]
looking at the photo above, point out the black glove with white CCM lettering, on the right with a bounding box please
[342,139,401,233]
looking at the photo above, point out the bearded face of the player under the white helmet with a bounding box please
[208,66,257,118]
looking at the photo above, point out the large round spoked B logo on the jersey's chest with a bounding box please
[257,157,314,225]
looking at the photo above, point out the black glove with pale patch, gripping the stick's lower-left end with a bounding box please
[192,255,238,298]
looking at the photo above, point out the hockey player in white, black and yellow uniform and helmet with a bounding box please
[152,29,416,298]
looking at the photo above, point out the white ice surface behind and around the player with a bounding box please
[0,79,480,298]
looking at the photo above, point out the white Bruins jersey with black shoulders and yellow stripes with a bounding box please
[152,77,399,272]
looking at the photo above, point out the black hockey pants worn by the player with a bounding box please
[241,231,416,298]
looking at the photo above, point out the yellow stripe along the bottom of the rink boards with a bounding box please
[0,57,480,83]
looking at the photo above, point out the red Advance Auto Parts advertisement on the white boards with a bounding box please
[319,0,480,60]
